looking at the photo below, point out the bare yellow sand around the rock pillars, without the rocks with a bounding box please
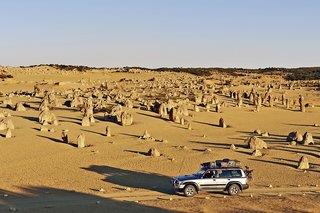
[0,68,320,212]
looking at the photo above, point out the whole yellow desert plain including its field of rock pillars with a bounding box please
[0,66,320,212]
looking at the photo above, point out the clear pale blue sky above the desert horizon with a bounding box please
[0,0,320,67]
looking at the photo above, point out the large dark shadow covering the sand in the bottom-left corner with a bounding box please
[0,187,172,213]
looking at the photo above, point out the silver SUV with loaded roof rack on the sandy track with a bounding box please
[172,159,252,197]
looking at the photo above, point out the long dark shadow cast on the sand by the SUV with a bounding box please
[82,165,173,194]
